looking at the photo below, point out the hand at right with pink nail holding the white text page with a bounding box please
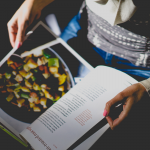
[103,83,147,130]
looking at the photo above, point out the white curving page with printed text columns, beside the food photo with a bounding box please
[21,66,137,150]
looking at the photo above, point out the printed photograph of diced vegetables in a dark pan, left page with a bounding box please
[0,23,90,123]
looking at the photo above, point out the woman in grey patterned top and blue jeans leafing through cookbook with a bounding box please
[8,0,150,130]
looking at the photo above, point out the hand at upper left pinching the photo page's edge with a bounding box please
[7,0,53,48]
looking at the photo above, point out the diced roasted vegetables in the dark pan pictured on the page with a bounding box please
[0,49,68,112]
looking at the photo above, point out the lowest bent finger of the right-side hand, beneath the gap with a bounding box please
[106,97,134,130]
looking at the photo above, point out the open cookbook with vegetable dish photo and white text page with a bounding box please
[0,22,137,150]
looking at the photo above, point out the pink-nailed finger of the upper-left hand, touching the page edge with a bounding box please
[15,23,26,48]
